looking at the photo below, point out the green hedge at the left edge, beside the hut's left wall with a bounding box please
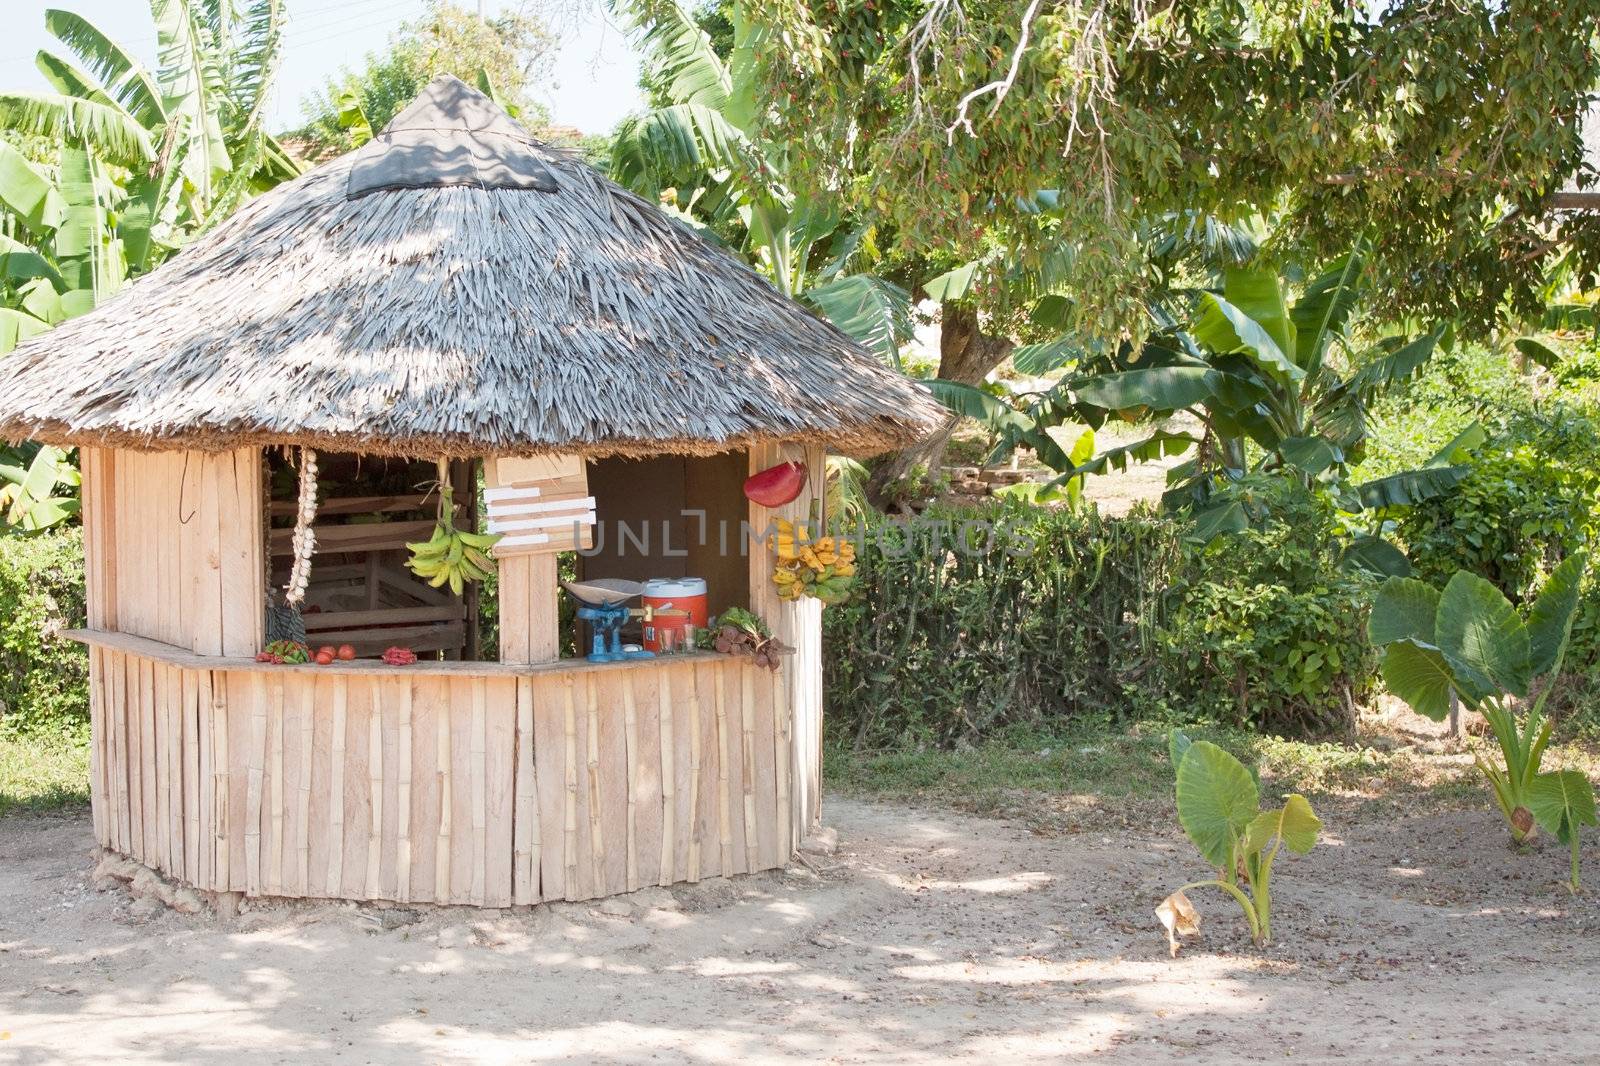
[0,530,90,735]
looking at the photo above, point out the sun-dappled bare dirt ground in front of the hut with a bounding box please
[0,799,1600,1066]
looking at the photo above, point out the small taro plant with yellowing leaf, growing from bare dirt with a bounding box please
[1155,730,1322,956]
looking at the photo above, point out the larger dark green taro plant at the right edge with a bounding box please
[1368,554,1594,857]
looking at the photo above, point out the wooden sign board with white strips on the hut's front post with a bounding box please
[483,456,595,559]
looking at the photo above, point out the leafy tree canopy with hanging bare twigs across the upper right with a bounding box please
[741,0,1600,335]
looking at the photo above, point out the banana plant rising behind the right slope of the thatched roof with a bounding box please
[610,0,914,358]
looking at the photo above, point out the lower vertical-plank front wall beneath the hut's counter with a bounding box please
[90,648,790,906]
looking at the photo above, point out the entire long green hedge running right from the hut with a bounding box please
[822,492,1373,747]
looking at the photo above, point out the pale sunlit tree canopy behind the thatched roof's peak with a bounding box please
[296,0,557,155]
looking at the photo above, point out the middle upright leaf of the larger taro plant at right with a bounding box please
[1434,570,1530,699]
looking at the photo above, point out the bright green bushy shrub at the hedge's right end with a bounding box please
[1158,495,1374,735]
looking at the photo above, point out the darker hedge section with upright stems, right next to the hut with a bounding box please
[822,501,1179,747]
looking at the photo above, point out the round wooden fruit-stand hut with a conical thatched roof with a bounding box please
[0,77,938,906]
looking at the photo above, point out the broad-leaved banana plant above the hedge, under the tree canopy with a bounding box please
[930,246,1466,560]
